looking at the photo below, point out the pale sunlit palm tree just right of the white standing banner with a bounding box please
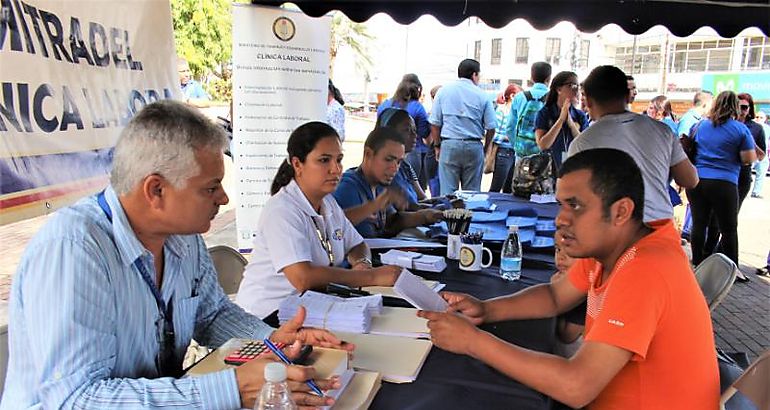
[329,11,375,78]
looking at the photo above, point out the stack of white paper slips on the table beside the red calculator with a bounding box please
[278,291,383,333]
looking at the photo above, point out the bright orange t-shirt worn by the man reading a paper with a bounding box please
[569,220,719,410]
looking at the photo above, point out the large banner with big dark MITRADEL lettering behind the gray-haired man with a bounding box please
[0,0,180,224]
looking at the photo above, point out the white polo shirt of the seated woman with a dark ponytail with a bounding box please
[235,180,364,318]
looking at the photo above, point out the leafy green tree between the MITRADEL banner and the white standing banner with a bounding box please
[171,0,232,101]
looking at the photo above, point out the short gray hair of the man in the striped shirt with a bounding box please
[110,100,228,195]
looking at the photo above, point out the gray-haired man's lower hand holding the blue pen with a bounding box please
[235,356,340,409]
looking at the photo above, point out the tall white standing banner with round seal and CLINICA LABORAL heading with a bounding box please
[233,4,331,251]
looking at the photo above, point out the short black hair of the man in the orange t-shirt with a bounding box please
[559,148,644,222]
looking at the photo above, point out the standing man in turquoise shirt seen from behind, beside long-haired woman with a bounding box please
[505,61,551,163]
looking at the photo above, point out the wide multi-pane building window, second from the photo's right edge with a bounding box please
[669,39,733,73]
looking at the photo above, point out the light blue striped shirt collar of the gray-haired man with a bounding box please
[104,185,188,266]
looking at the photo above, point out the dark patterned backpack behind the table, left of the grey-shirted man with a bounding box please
[513,151,555,198]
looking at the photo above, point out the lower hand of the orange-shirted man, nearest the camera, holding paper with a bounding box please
[417,310,480,355]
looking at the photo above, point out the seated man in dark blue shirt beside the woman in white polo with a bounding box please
[333,127,443,238]
